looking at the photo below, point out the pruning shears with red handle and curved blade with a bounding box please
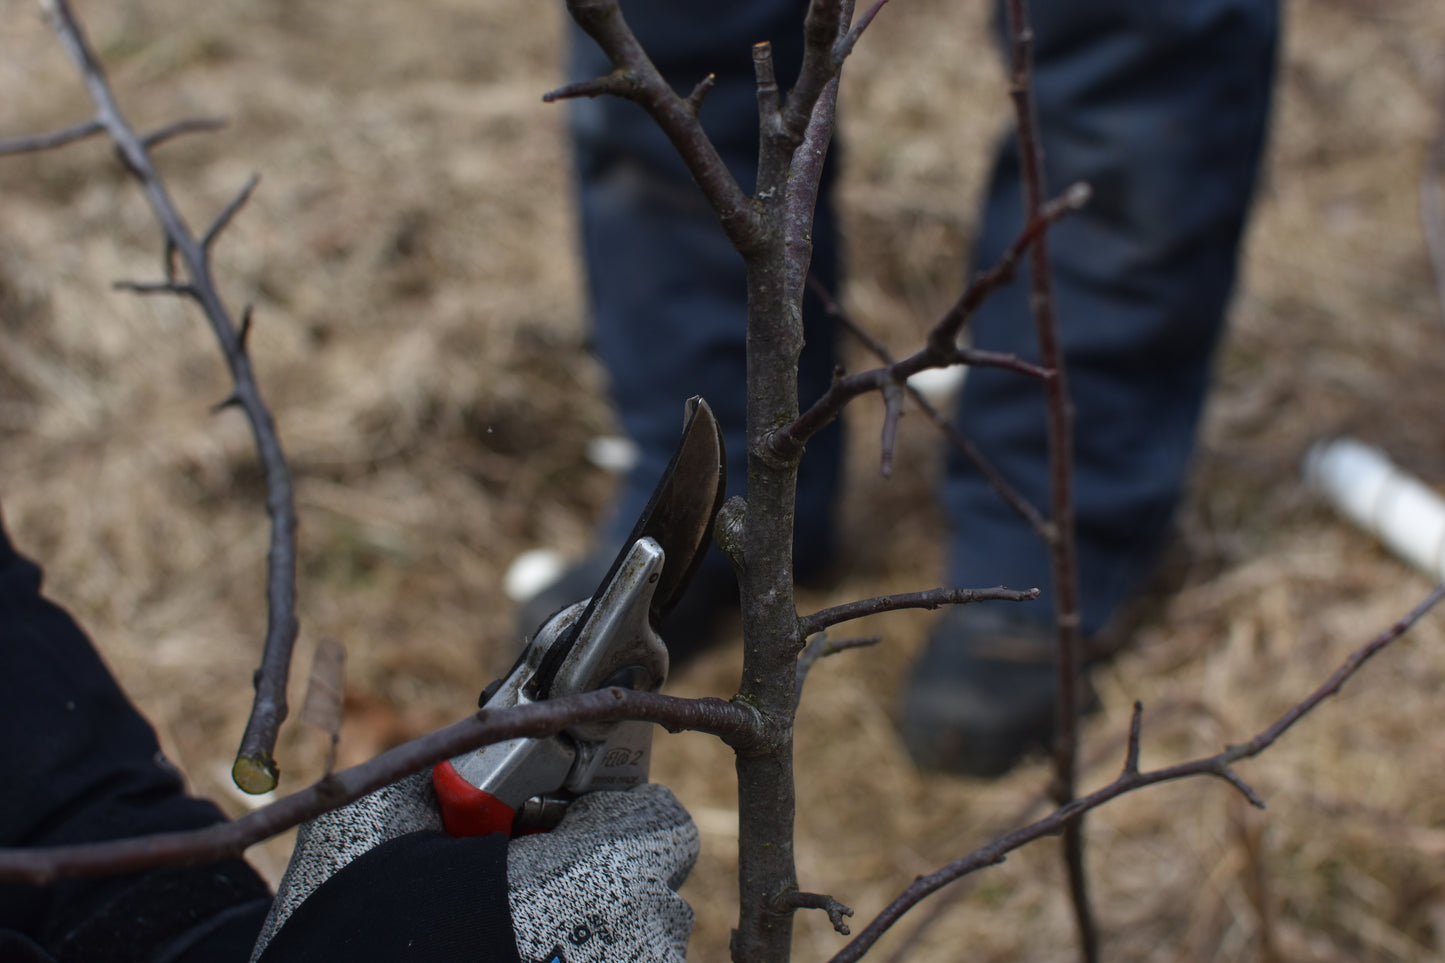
[432,398,727,836]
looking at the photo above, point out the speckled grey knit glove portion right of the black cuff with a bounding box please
[507,785,698,963]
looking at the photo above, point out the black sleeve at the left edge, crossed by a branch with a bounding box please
[0,517,270,963]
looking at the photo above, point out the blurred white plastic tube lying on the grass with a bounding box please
[1305,438,1445,580]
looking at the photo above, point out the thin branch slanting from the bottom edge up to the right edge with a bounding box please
[829,583,1445,963]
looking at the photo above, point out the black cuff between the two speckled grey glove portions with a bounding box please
[262,831,520,963]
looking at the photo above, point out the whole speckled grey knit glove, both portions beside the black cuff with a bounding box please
[251,772,698,963]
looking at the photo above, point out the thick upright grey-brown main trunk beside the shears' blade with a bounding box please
[731,0,847,960]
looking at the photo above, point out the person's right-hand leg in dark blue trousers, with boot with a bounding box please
[905,0,1279,766]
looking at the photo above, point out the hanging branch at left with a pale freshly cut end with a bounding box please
[42,0,298,792]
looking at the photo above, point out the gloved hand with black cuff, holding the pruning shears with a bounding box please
[251,774,698,963]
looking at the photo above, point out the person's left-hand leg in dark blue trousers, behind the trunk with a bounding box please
[537,0,841,651]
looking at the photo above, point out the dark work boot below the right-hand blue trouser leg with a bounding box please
[900,604,1097,778]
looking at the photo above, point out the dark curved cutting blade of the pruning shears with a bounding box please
[532,395,727,698]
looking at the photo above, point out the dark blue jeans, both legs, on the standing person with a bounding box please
[571,0,1279,635]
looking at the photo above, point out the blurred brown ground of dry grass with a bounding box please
[0,0,1445,963]
